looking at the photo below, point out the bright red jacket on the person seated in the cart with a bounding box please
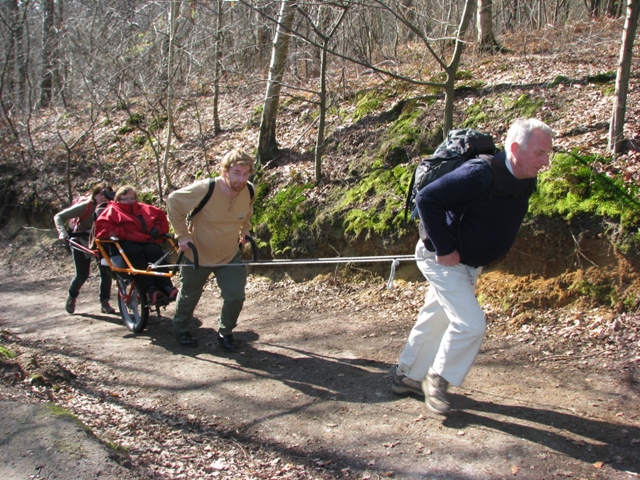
[96,202,169,243]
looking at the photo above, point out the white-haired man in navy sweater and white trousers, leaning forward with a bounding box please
[392,119,554,415]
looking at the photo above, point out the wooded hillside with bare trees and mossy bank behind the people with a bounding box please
[0,0,640,296]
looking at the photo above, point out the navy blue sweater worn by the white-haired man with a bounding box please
[416,152,535,267]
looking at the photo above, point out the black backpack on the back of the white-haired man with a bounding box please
[404,128,498,222]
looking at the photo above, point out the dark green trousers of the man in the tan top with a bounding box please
[173,253,247,335]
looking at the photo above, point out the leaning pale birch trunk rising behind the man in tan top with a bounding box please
[257,0,297,164]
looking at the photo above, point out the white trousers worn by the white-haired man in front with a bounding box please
[398,241,486,387]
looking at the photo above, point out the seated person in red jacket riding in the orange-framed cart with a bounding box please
[96,185,178,305]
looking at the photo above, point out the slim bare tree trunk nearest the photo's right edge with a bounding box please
[608,0,640,153]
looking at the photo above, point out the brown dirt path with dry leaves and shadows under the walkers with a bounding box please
[0,260,640,479]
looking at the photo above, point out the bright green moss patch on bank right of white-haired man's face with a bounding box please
[530,153,640,229]
